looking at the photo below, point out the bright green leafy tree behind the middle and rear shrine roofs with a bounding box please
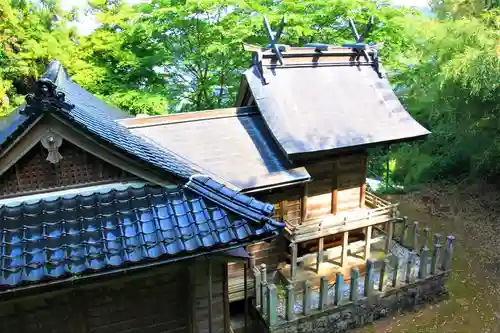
[75,0,422,113]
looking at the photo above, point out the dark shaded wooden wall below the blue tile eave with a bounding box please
[0,260,225,333]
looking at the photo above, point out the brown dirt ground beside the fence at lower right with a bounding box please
[358,184,500,333]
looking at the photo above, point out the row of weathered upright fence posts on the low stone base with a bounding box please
[253,230,455,327]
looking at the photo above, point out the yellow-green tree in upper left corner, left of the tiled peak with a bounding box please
[0,0,75,116]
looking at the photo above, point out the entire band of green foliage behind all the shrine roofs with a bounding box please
[0,0,500,190]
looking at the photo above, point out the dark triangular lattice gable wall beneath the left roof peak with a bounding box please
[0,141,134,198]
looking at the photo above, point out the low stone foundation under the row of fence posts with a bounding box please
[255,272,449,333]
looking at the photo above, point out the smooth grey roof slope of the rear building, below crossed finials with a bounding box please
[245,66,429,156]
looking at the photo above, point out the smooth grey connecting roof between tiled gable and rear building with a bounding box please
[121,107,310,191]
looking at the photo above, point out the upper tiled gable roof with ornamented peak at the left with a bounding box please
[0,61,205,180]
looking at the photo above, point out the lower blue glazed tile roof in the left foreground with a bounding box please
[0,176,283,289]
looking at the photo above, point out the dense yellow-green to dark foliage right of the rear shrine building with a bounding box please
[394,14,500,183]
